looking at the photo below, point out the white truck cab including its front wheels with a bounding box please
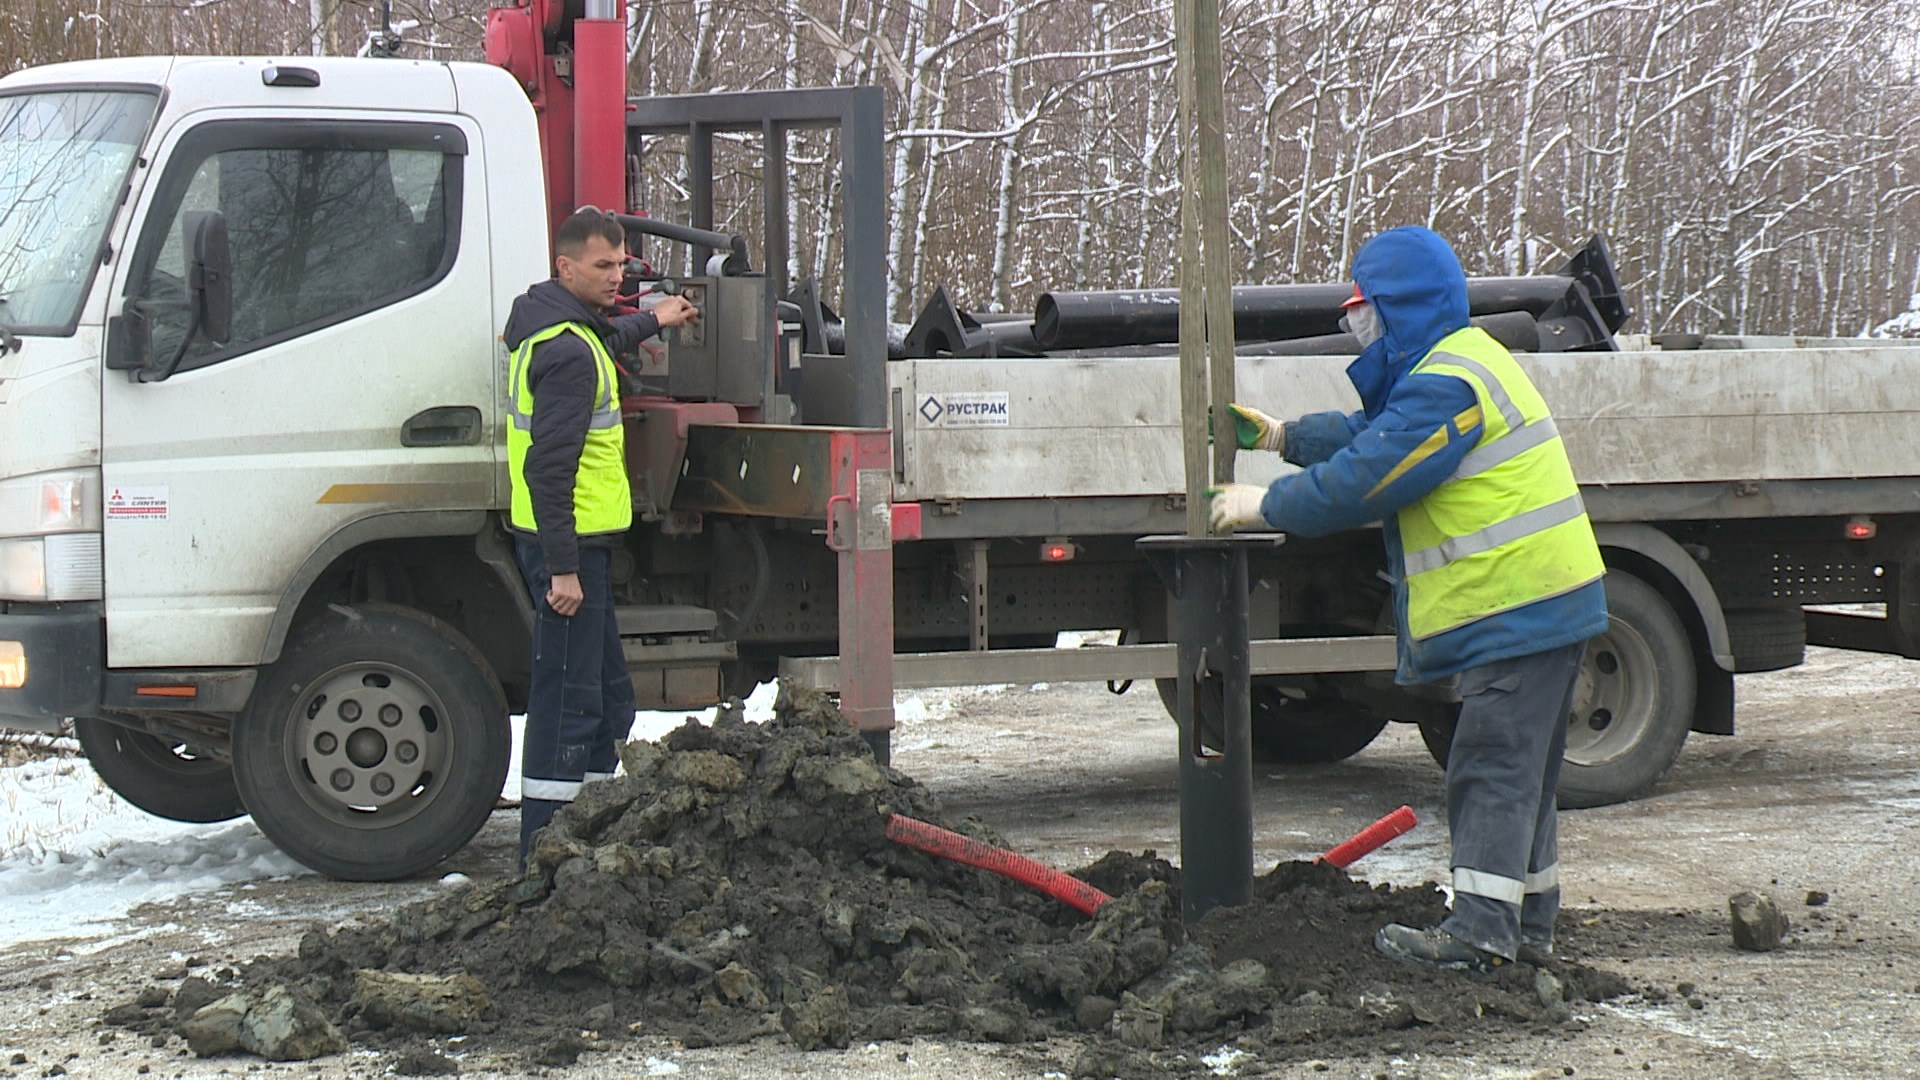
[0,58,547,876]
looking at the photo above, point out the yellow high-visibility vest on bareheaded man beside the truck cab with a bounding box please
[507,323,634,536]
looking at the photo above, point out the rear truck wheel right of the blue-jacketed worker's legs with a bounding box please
[1421,571,1699,809]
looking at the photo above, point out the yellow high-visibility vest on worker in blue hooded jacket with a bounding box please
[1398,329,1605,640]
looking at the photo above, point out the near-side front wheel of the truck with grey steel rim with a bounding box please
[232,603,511,882]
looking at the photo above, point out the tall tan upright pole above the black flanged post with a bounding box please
[1173,0,1235,536]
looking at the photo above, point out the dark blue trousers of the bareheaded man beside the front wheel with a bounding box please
[515,536,634,869]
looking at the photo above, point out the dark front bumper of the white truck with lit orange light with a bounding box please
[0,603,108,732]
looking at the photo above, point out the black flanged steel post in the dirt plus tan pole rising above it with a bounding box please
[1140,0,1279,922]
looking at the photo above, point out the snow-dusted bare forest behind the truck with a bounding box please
[0,0,1920,334]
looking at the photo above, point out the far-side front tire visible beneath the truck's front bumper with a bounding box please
[73,719,246,824]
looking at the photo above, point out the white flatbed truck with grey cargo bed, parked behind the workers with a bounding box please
[0,48,1920,878]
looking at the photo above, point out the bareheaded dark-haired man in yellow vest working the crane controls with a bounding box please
[503,208,695,869]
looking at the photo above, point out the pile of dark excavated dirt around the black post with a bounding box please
[108,684,1630,1076]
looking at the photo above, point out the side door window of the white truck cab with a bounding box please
[129,125,461,371]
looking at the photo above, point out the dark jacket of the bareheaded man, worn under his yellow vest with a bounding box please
[503,281,660,575]
